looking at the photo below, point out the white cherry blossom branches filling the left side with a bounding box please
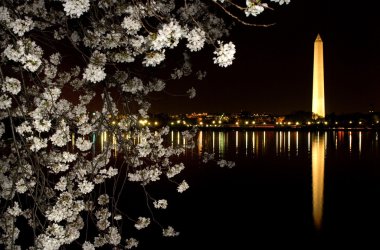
[0,0,290,249]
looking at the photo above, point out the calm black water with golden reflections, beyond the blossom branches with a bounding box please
[140,131,380,249]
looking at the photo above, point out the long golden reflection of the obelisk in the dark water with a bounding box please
[311,132,326,230]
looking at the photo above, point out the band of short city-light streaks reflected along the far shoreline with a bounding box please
[75,131,380,159]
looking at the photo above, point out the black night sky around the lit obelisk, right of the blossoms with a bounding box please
[151,0,380,114]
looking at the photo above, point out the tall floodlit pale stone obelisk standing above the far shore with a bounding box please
[312,34,325,119]
